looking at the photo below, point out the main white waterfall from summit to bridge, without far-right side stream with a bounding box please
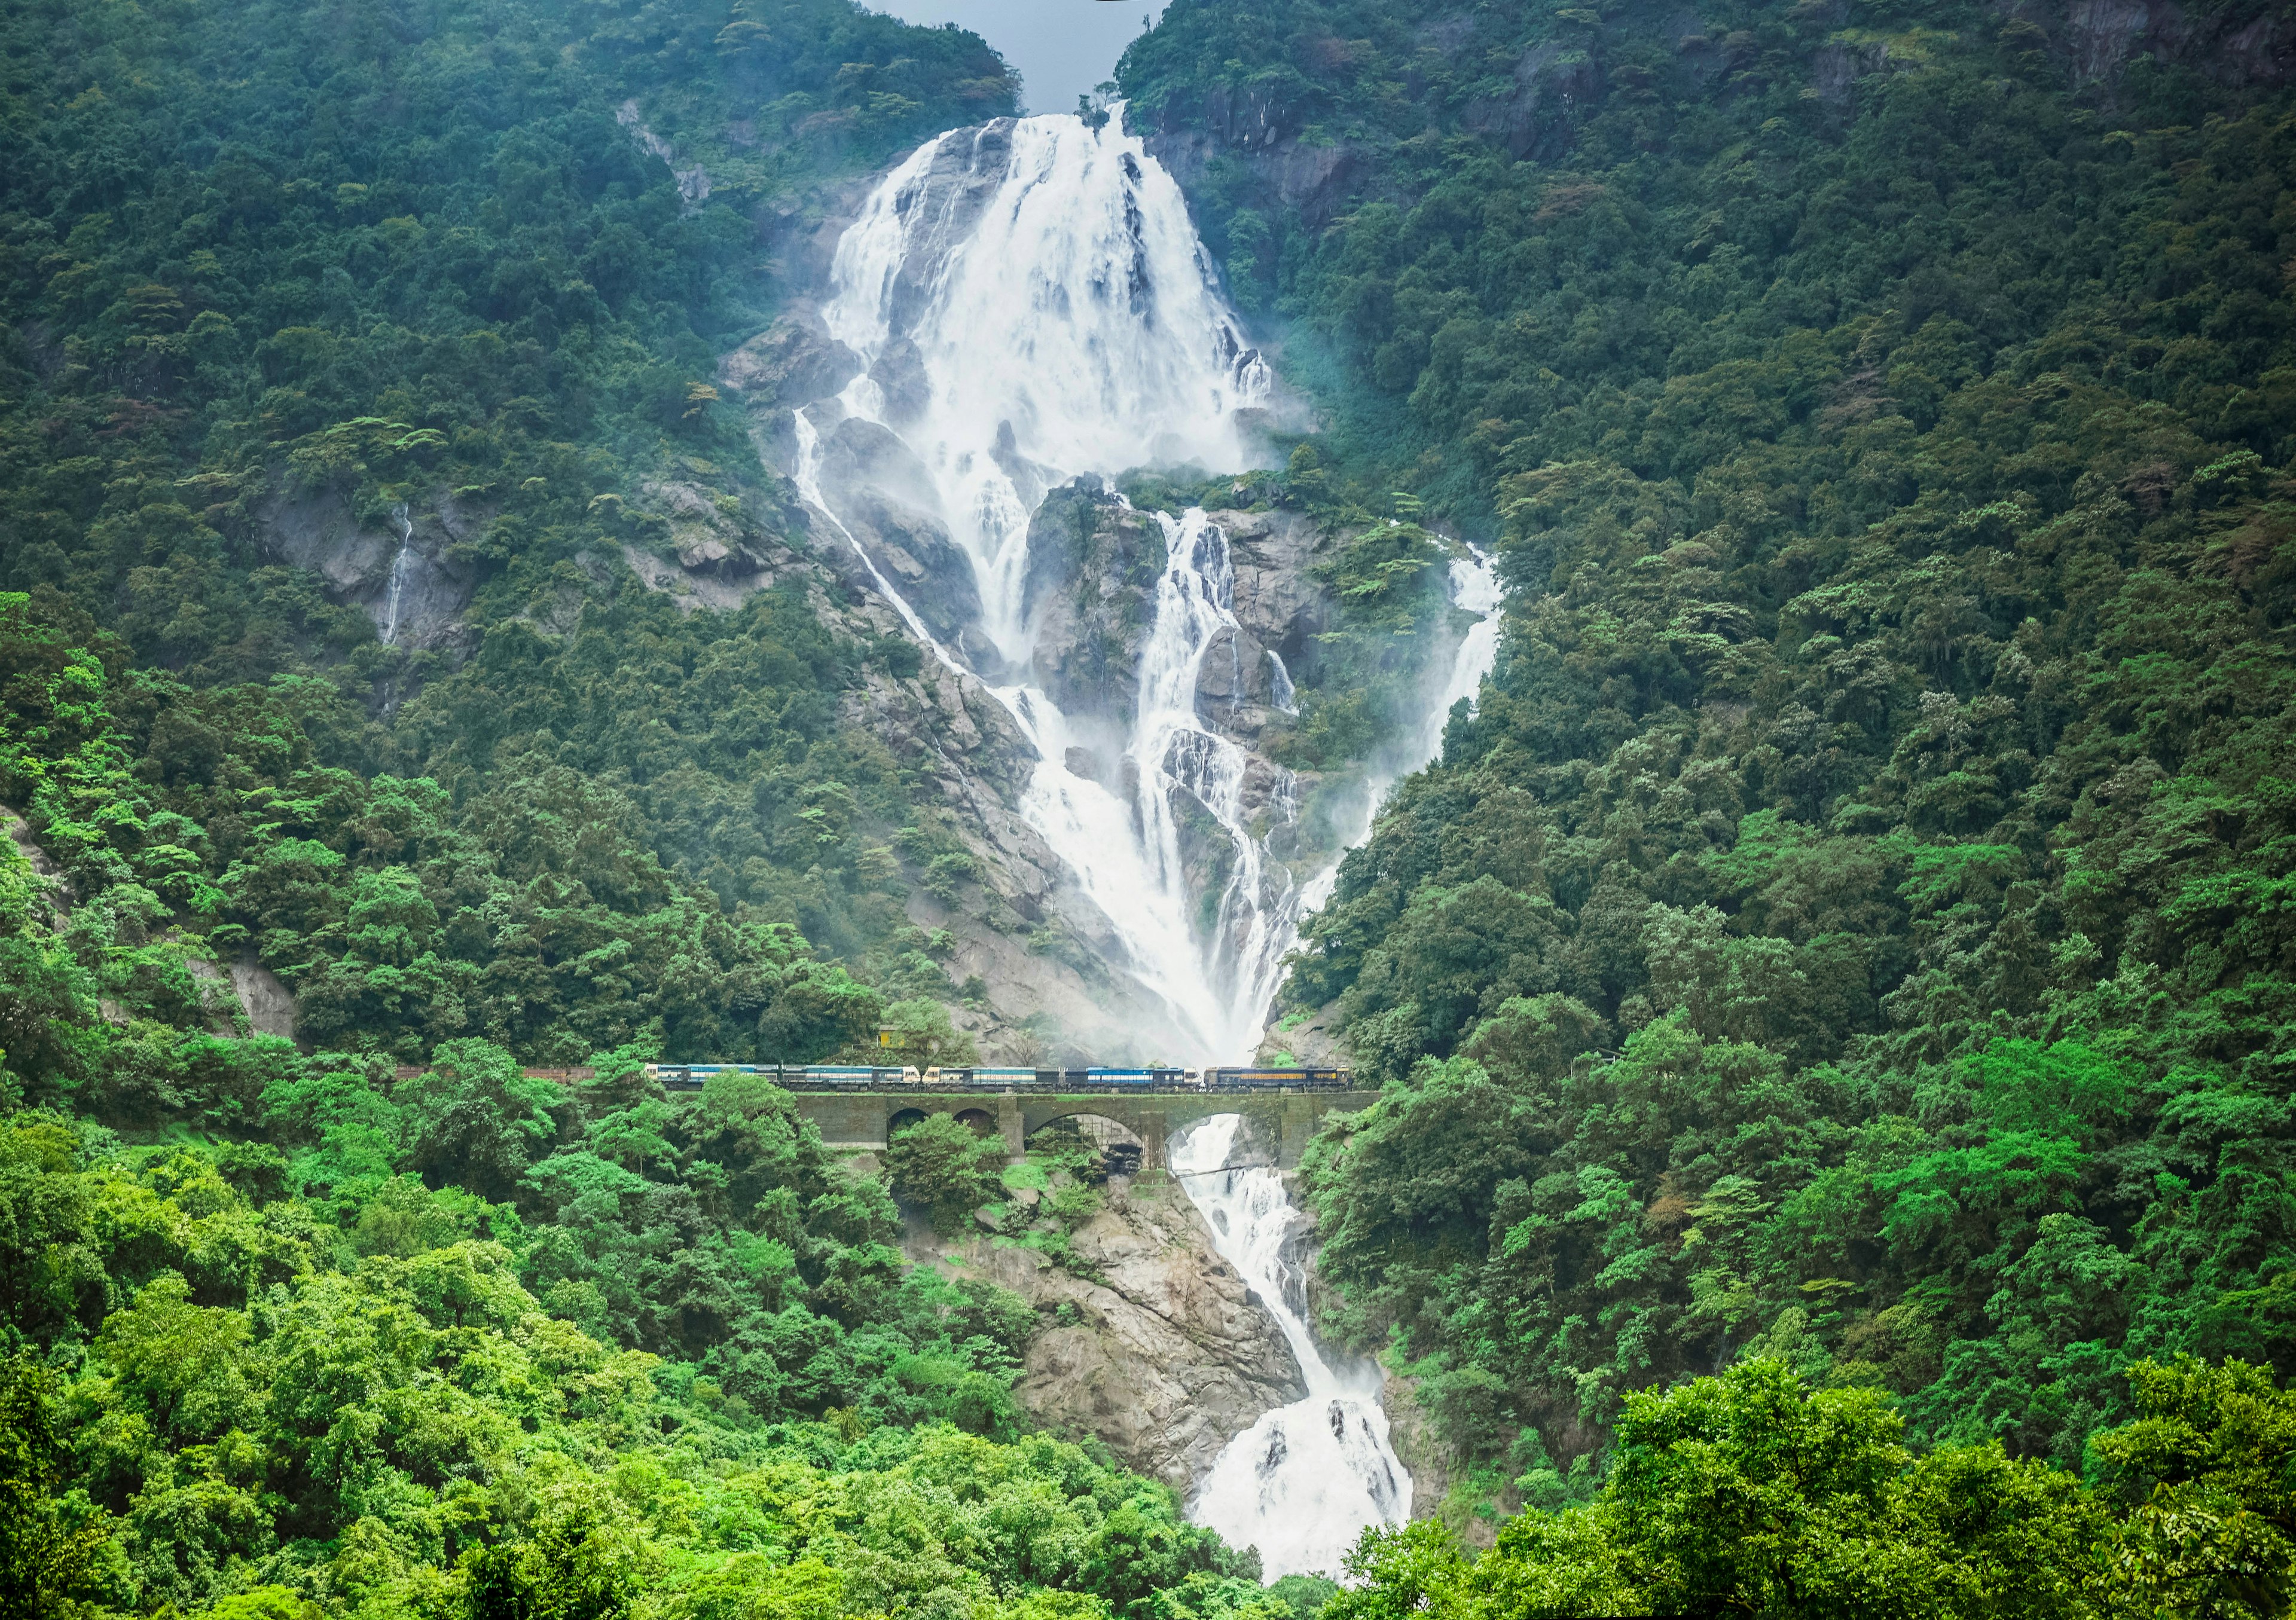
[796,115,1293,1060]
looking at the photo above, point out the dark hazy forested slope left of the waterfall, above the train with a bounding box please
[0,0,1012,1046]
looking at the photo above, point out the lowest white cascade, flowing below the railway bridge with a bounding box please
[1167,1113,1412,1581]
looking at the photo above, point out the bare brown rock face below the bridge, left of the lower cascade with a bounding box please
[918,1175,1306,1491]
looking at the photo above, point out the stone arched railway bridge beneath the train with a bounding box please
[792,1090,1380,1170]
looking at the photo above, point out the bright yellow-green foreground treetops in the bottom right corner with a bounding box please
[1325,1358,2296,1620]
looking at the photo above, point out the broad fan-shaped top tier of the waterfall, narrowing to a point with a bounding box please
[822,108,1274,661]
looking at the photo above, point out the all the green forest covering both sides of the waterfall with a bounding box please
[0,0,2296,1620]
